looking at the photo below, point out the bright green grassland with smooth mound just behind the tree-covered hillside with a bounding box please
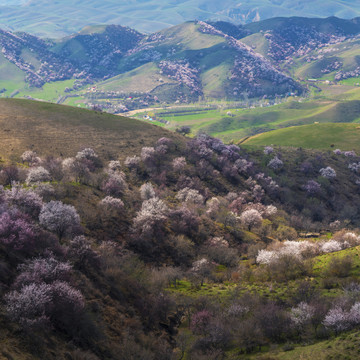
[148,99,360,141]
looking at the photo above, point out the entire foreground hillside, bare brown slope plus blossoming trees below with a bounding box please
[0,99,360,360]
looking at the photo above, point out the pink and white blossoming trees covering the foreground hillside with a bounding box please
[0,134,360,359]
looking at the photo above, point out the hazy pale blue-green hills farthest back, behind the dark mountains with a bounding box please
[0,0,360,37]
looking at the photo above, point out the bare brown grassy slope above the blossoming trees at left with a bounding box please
[0,99,182,161]
